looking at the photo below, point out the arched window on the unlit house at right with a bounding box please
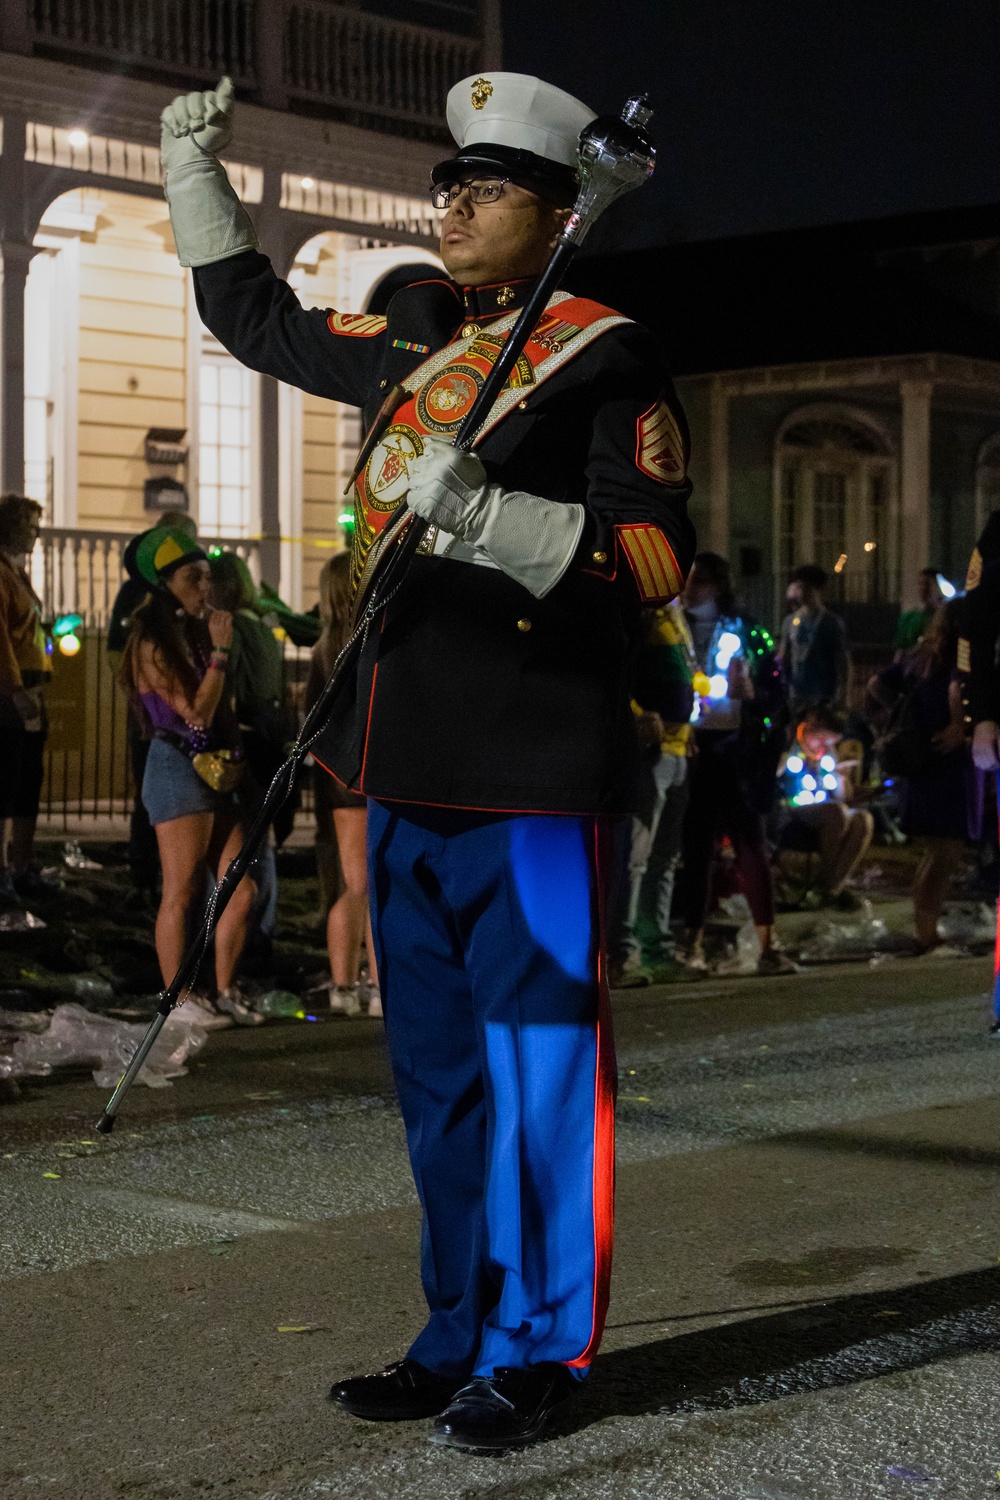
[775,404,897,603]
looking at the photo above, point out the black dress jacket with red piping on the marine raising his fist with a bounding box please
[195,251,694,815]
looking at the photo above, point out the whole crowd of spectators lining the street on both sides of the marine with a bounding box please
[0,497,984,1026]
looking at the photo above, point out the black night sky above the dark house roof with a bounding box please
[504,0,1000,249]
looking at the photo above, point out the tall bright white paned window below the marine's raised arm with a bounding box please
[198,332,253,537]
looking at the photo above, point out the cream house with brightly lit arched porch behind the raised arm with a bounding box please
[0,0,499,623]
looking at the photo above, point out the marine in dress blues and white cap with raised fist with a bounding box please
[165,72,694,1449]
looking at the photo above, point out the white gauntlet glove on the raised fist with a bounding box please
[160,78,256,266]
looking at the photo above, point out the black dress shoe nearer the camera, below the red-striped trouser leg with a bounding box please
[430,1365,576,1454]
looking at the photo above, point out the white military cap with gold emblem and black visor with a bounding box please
[432,72,595,201]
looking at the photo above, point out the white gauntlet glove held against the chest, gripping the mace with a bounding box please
[406,438,586,599]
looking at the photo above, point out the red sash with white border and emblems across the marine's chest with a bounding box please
[351,293,630,588]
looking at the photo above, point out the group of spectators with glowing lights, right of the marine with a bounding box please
[610,552,984,986]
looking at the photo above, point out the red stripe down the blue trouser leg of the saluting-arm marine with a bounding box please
[567,819,618,1370]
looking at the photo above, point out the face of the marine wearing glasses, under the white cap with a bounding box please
[441,171,565,287]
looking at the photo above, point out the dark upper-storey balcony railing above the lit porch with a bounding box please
[17,0,481,135]
